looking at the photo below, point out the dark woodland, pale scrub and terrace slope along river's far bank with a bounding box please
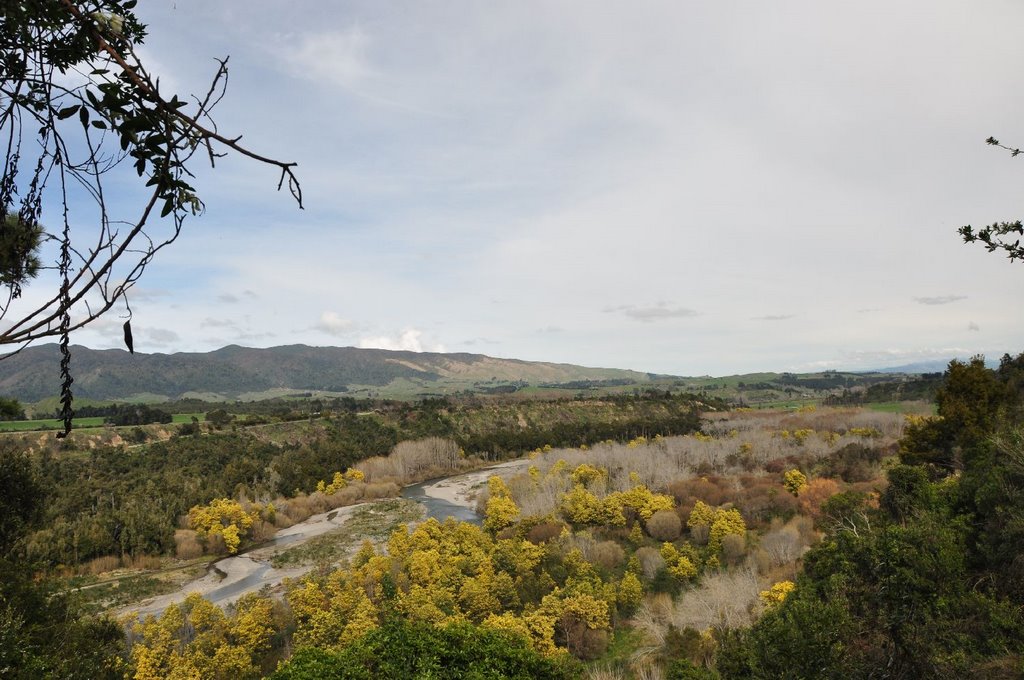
[14,394,699,571]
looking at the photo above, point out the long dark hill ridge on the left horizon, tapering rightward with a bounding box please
[0,344,652,402]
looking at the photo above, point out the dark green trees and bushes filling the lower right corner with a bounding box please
[717,354,1024,680]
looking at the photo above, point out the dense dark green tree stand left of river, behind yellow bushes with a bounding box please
[28,409,398,566]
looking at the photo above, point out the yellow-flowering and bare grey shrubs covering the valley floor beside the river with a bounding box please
[117,401,903,678]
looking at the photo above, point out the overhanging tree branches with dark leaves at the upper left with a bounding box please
[0,0,302,433]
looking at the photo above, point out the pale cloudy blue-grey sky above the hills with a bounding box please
[14,0,1024,376]
